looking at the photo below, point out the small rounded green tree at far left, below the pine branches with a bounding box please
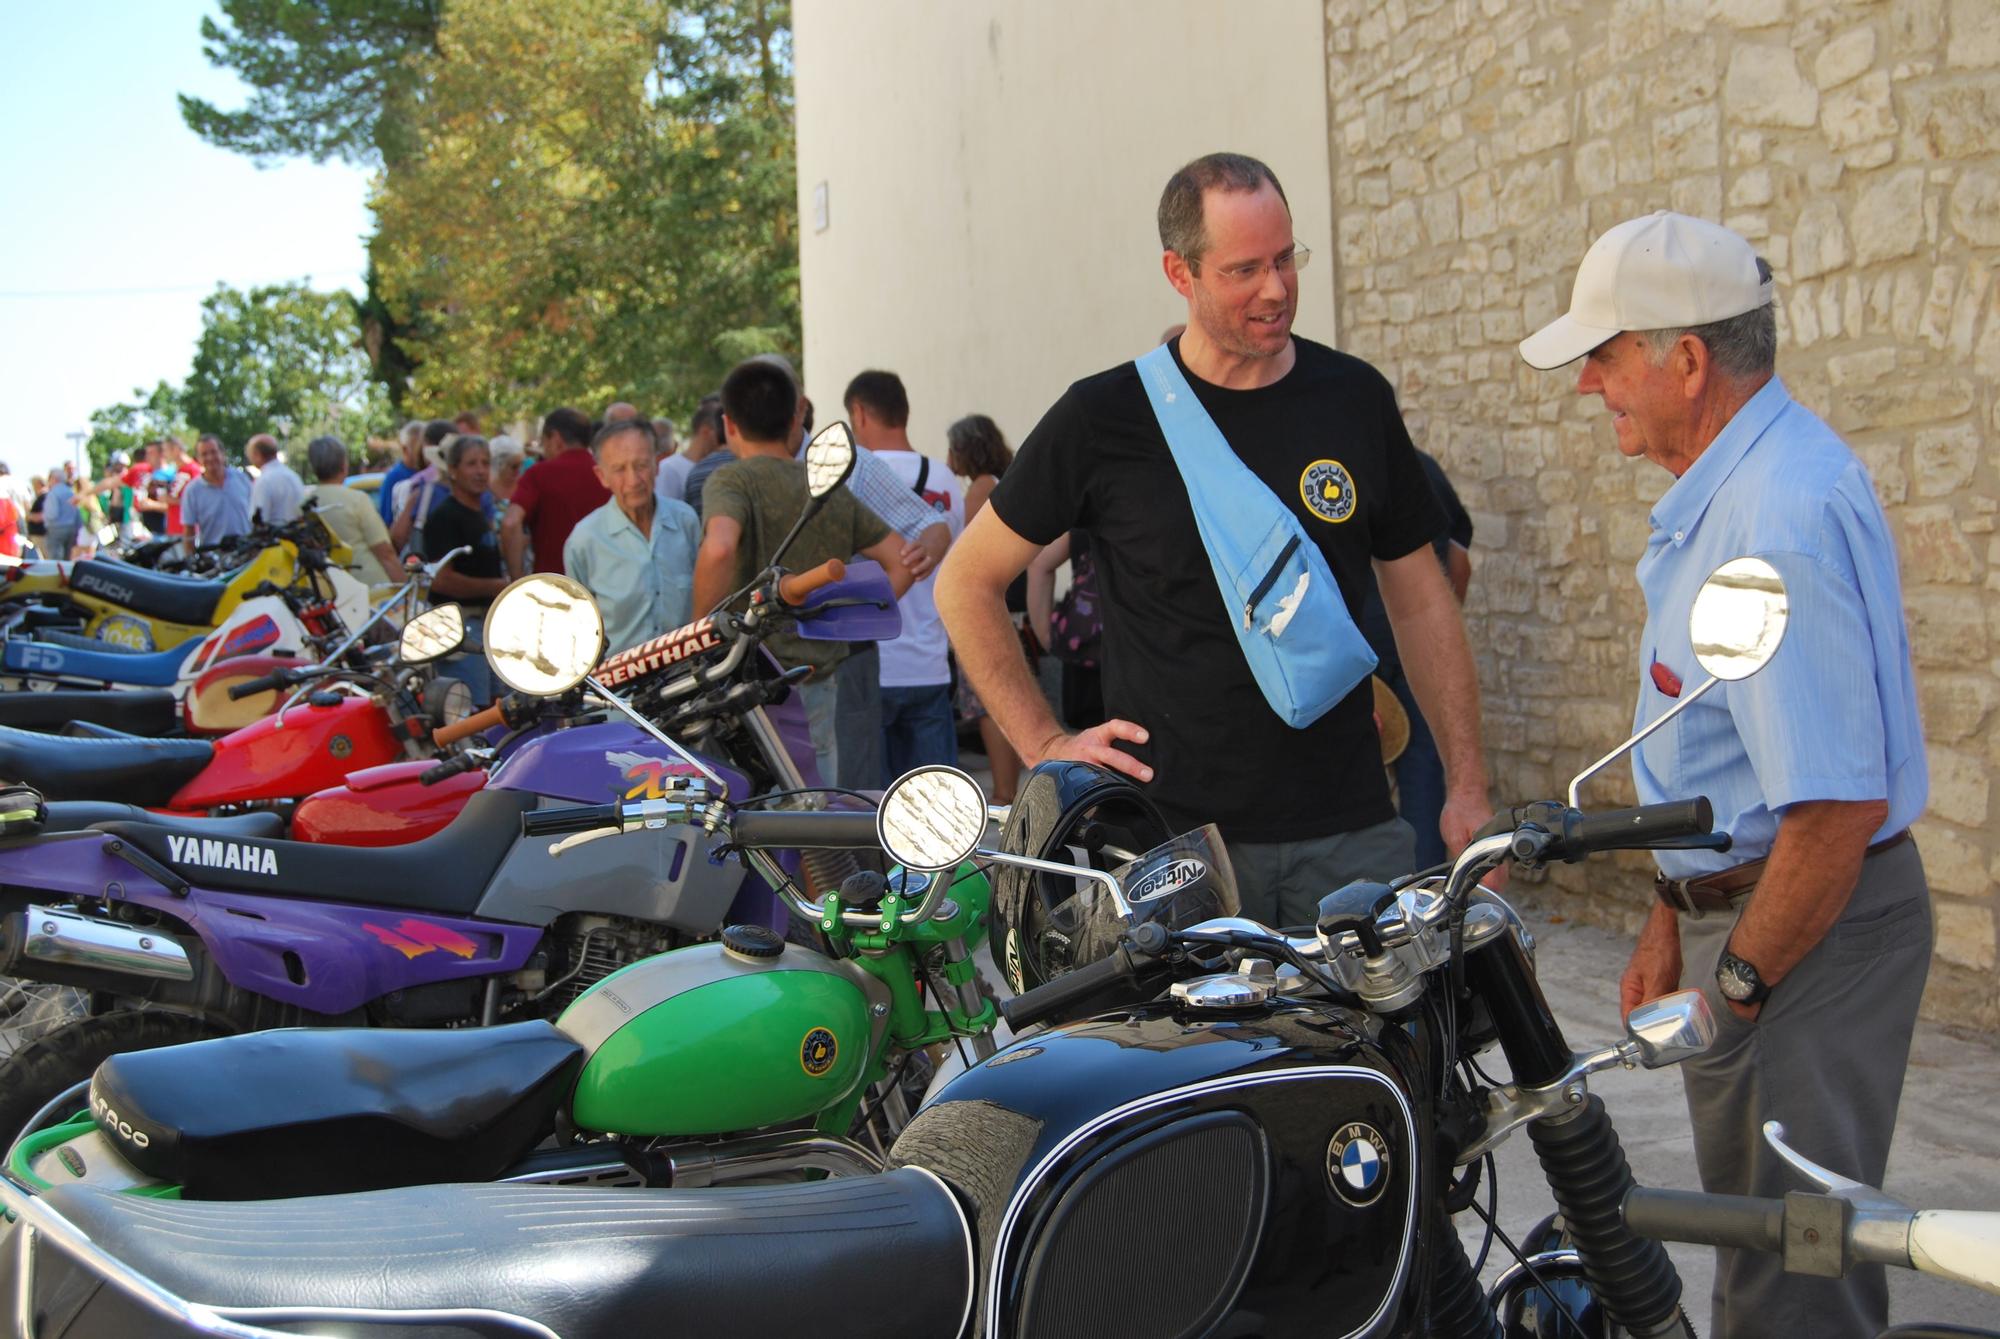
[180,284,390,452]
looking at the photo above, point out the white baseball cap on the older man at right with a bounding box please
[1520,210,1772,370]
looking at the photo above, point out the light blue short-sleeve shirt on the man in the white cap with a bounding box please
[1632,378,1930,879]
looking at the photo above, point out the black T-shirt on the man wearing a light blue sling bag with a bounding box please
[992,340,1444,841]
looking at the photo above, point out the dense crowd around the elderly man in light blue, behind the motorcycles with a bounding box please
[352,354,1056,801]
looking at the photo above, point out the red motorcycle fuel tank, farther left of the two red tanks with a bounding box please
[170,695,402,809]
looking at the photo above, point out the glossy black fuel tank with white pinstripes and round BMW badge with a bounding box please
[890,1003,1420,1339]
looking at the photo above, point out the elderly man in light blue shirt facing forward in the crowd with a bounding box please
[562,420,700,652]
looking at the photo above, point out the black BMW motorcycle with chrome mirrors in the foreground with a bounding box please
[11,568,1984,1339]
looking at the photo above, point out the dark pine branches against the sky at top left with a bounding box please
[180,0,444,166]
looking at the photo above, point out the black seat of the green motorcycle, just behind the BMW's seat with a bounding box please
[90,1021,584,1199]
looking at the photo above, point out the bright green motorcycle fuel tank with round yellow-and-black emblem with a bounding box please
[556,927,886,1135]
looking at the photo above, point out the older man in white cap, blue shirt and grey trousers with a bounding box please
[1520,212,1932,1339]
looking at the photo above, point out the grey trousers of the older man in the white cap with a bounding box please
[1680,839,1932,1339]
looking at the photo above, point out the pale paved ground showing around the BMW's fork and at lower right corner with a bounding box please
[964,755,2000,1339]
